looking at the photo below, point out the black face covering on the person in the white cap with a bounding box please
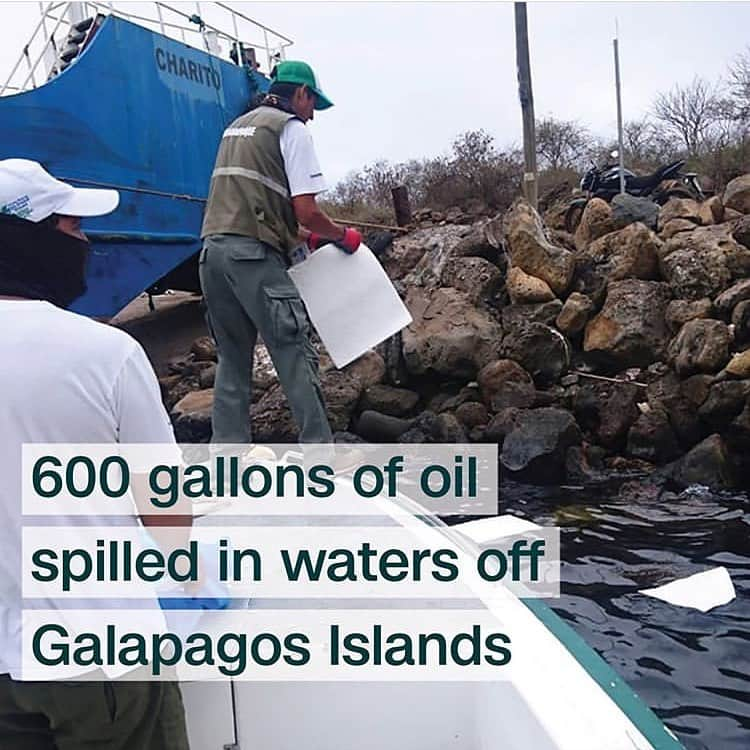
[0,216,89,308]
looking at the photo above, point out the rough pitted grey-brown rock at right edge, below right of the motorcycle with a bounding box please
[659,224,750,300]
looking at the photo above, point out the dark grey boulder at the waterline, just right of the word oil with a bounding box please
[500,408,581,484]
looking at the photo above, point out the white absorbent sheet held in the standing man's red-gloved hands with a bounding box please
[289,244,412,368]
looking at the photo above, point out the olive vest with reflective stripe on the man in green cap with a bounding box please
[201,107,299,252]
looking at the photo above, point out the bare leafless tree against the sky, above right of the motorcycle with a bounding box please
[654,76,722,156]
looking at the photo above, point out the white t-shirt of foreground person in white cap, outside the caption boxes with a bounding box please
[0,300,174,677]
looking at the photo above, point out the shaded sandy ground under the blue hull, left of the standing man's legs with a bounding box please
[110,292,208,375]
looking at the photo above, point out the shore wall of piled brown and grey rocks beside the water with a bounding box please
[160,175,750,488]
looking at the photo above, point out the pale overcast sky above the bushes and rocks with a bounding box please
[0,2,750,185]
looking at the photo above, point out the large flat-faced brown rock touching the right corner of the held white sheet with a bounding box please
[401,287,503,379]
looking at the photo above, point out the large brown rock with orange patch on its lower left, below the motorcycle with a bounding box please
[583,279,670,369]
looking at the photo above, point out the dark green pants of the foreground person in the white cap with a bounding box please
[0,674,188,750]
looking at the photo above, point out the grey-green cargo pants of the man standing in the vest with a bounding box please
[199,234,332,443]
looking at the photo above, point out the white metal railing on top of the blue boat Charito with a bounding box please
[0,2,293,96]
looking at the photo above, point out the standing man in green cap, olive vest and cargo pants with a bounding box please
[200,60,362,443]
